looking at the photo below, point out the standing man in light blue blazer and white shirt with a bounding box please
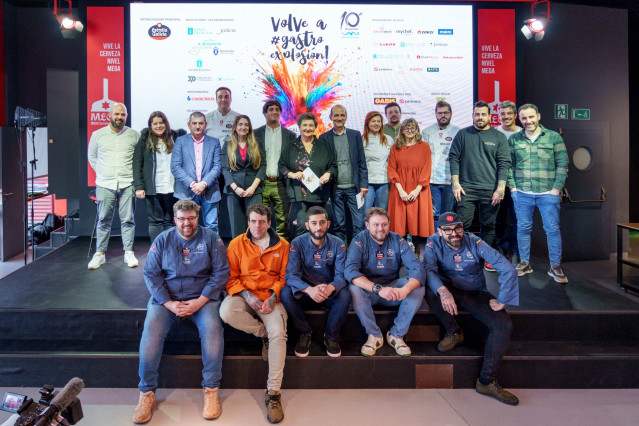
[171,111,222,233]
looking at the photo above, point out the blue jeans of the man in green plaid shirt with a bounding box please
[510,191,561,266]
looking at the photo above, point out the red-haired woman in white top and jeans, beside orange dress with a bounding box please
[362,111,394,212]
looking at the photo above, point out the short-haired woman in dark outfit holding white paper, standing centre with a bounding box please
[279,113,337,239]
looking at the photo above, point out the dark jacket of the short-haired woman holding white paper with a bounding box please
[279,137,337,203]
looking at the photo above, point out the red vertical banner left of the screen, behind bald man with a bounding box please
[87,7,124,186]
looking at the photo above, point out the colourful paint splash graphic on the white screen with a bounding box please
[256,46,342,133]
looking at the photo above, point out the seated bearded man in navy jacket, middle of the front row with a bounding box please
[281,206,351,357]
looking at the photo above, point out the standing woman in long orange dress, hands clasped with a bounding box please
[388,118,435,253]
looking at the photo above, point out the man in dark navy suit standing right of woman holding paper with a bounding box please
[320,105,368,242]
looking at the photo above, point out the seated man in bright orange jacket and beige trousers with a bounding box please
[220,204,289,423]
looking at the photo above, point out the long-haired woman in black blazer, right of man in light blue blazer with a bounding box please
[222,115,266,238]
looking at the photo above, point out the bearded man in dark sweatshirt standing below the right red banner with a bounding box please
[448,101,510,271]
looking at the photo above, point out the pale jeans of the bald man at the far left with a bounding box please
[95,185,136,252]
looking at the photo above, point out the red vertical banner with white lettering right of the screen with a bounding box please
[477,9,516,126]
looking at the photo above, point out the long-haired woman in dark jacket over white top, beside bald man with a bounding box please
[133,111,186,241]
